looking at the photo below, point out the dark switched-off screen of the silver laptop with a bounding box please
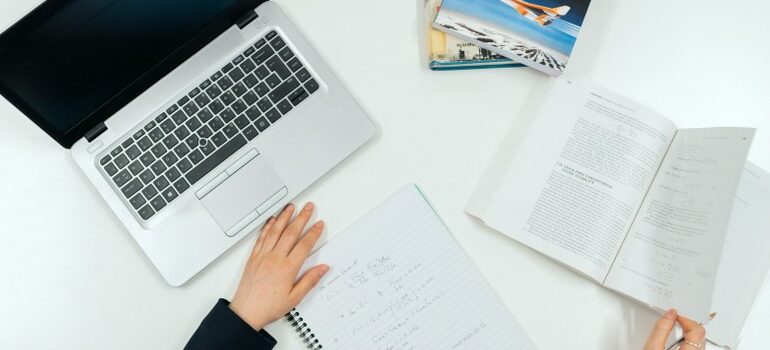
[0,0,252,148]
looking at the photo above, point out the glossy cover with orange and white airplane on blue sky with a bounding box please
[433,0,591,75]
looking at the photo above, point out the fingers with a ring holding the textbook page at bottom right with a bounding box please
[644,309,706,350]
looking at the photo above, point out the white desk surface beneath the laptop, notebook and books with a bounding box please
[0,0,770,349]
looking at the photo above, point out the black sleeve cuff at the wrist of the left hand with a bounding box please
[184,299,278,350]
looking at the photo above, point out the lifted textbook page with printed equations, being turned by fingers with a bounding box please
[604,128,754,323]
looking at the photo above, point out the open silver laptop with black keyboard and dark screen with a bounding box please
[0,0,375,286]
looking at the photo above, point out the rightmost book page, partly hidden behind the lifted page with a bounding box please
[706,162,770,349]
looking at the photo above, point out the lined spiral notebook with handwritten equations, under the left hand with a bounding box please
[287,185,535,350]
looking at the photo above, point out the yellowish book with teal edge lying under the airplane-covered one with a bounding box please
[425,0,523,70]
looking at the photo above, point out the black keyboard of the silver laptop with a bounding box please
[99,31,319,220]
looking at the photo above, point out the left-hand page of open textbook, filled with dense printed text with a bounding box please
[484,79,676,283]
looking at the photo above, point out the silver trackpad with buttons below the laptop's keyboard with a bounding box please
[201,156,288,236]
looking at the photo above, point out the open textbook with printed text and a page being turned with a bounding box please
[467,79,770,348]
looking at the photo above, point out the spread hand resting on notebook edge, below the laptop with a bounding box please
[230,203,329,330]
